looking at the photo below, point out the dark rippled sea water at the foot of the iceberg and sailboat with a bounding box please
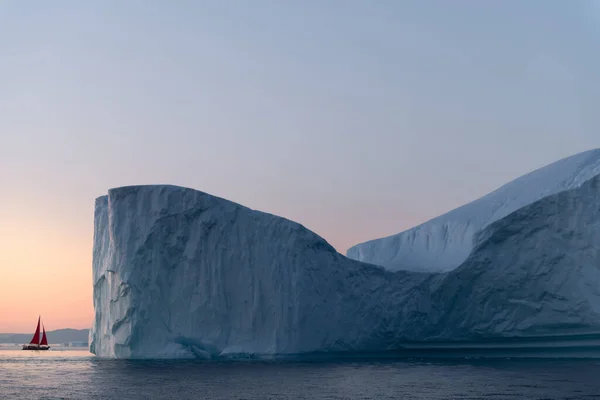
[0,346,600,400]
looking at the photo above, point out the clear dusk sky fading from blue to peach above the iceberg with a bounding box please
[0,0,600,332]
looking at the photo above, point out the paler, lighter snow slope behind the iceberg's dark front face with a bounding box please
[346,149,600,272]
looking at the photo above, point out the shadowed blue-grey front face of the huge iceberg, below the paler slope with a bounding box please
[90,155,600,358]
